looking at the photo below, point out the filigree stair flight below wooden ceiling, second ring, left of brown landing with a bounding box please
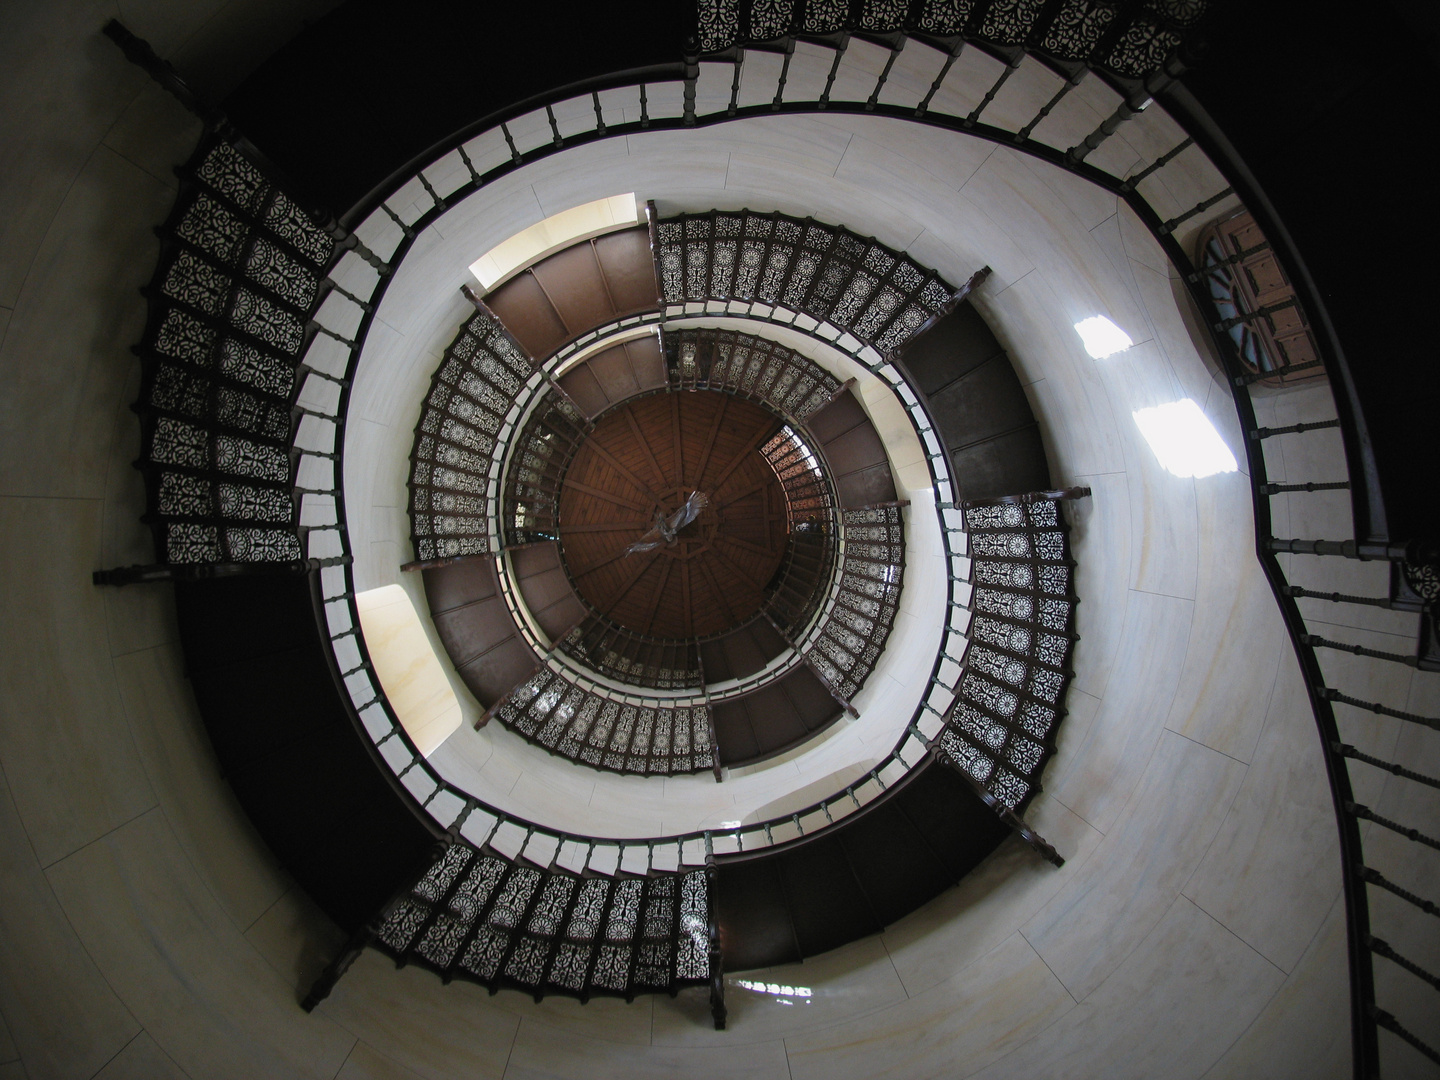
[495,667,714,776]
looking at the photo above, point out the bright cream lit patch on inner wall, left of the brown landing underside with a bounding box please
[356,585,461,757]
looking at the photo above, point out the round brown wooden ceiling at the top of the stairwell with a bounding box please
[560,390,786,638]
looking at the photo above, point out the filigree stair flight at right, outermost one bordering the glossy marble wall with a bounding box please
[939,488,1089,814]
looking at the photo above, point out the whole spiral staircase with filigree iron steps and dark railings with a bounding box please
[96,3,1434,1076]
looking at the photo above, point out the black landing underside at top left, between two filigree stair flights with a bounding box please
[225,0,691,213]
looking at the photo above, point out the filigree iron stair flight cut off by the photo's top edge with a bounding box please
[697,0,1211,79]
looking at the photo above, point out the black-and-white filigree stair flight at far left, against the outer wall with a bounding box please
[134,135,337,567]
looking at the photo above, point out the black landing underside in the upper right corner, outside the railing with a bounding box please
[1184,0,1440,540]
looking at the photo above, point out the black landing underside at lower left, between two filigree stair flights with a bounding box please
[176,575,435,933]
